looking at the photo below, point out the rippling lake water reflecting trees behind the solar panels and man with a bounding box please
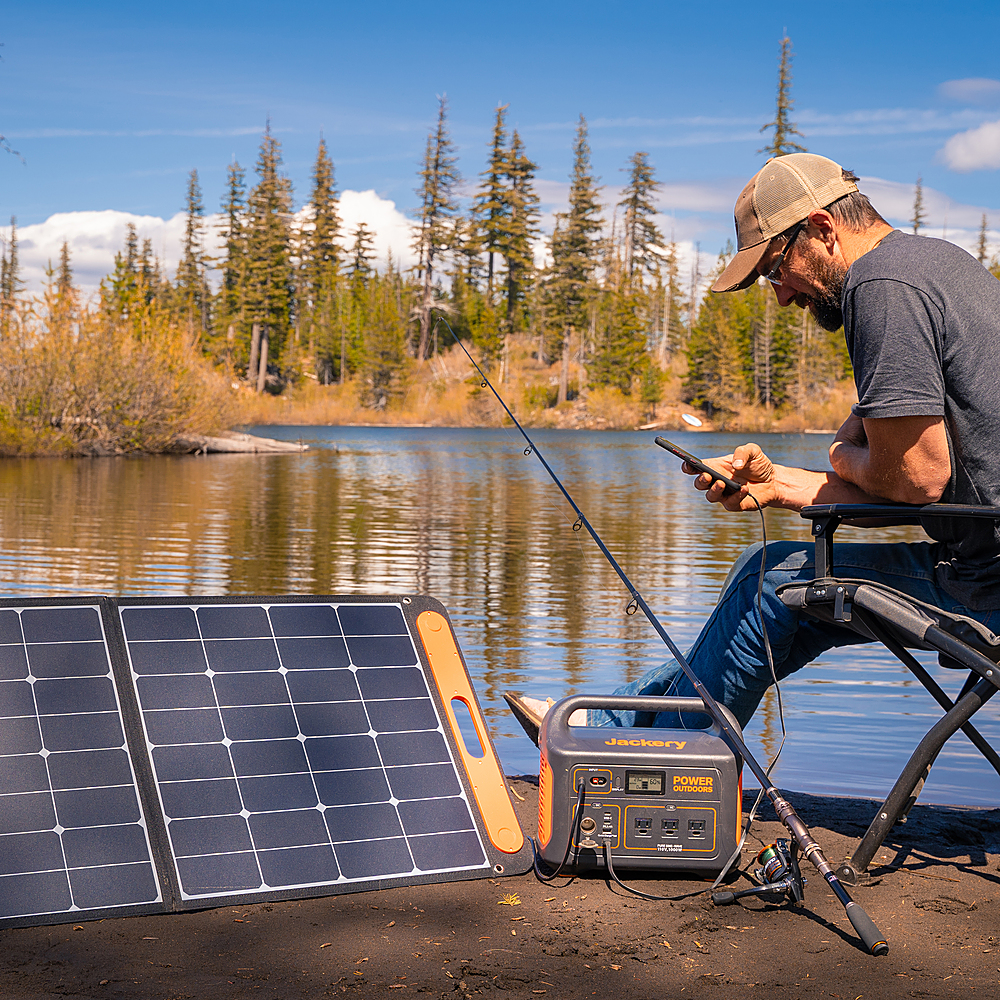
[0,427,1000,806]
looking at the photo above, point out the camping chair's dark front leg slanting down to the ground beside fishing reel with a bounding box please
[837,680,997,885]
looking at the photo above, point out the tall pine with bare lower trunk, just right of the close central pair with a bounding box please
[545,115,604,403]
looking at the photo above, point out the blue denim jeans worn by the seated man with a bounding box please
[587,542,1000,729]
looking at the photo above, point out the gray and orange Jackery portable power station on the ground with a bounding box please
[538,695,743,871]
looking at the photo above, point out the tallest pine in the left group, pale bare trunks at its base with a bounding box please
[246,122,293,392]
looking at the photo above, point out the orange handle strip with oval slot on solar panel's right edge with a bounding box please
[417,611,524,854]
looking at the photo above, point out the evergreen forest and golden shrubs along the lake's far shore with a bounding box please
[0,39,996,454]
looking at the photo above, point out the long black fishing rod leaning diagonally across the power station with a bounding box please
[437,315,889,955]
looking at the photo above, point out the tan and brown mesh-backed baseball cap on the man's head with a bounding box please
[712,153,858,292]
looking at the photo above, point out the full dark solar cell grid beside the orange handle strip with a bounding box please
[121,602,489,899]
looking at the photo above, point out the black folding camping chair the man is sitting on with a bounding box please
[778,504,1000,885]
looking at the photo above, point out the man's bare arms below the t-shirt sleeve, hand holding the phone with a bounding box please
[684,414,951,510]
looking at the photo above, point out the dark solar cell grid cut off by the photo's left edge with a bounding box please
[0,604,161,918]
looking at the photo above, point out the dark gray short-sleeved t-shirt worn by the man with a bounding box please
[843,231,1000,611]
